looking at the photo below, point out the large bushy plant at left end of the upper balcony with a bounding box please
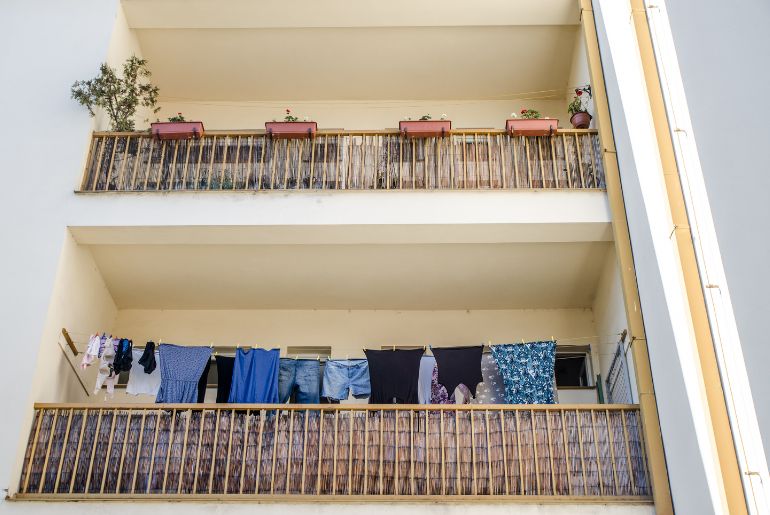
[71,55,160,131]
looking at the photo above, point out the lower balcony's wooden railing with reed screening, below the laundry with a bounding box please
[14,404,651,502]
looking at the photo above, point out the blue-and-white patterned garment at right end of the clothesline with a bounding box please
[492,341,556,404]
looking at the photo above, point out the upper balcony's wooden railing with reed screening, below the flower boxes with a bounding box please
[80,130,604,192]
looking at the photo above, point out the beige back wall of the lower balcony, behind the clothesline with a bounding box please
[100,309,595,402]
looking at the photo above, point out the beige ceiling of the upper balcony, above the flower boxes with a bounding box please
[123,0,578,101]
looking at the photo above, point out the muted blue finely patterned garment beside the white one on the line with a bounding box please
[155,343,211,403]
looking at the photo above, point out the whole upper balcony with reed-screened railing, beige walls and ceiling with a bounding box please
[77,0,604,200]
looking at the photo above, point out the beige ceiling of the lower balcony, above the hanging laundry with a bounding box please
[89,241,611,310]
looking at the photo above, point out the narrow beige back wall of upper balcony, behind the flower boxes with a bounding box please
[153,98,570,130]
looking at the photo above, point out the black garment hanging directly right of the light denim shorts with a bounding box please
[364,349,425,404]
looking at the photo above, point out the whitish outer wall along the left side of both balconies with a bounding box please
[0,0,117,509]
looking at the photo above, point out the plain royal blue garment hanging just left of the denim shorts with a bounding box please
[227,349,281,403]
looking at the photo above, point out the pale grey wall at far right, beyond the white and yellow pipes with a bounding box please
[666,0,770,472]
